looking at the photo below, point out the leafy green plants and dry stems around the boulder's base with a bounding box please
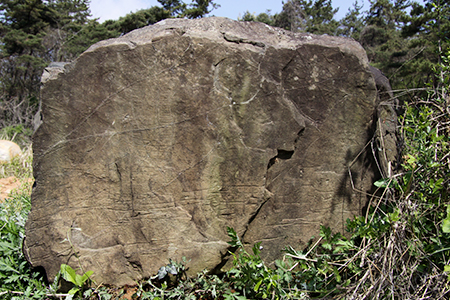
[0,68,450,299]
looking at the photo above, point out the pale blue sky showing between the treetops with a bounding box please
[91,0,369,22]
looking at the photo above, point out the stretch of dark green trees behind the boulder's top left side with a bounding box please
[0,0,218,127]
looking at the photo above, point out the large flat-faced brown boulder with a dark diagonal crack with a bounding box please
[25,18,394,285]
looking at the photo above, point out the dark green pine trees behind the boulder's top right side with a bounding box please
[241,0,450,101]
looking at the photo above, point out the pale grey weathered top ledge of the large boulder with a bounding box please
[86,17,367,62]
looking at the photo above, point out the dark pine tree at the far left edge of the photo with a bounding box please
[0,0,57,126]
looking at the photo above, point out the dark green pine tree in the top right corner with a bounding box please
[359,0,450,97]
